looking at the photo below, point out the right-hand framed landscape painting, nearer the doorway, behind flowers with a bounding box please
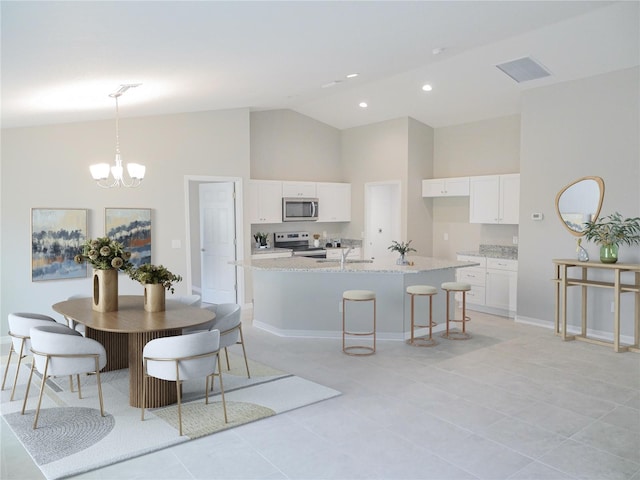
[104,208,151,267]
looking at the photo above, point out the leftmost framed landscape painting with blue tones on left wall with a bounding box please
[31,208,87,282]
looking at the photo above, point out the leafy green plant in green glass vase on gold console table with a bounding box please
[583,212,640,263]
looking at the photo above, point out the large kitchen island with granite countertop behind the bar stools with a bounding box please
[238,256,477,340]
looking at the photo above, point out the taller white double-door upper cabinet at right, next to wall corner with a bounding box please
[469,173,520,225]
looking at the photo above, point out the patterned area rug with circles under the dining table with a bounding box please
[0,355,340,479]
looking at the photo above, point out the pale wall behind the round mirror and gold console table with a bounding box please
[518,68,640,335]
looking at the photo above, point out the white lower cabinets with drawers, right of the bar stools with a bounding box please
[456,255,518,317]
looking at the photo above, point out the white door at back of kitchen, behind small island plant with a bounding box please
[364,182,401,258]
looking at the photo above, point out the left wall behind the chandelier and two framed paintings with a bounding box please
[0,109,249,335]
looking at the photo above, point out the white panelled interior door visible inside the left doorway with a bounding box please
[199,182,237,303]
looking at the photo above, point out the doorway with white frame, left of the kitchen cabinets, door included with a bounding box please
[185,176,244,304]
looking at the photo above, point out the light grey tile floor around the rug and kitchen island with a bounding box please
[0,312,640,480]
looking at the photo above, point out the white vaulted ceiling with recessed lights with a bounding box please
[0,0,640,129]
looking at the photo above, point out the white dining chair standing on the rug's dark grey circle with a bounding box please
[22,324,107,429]
